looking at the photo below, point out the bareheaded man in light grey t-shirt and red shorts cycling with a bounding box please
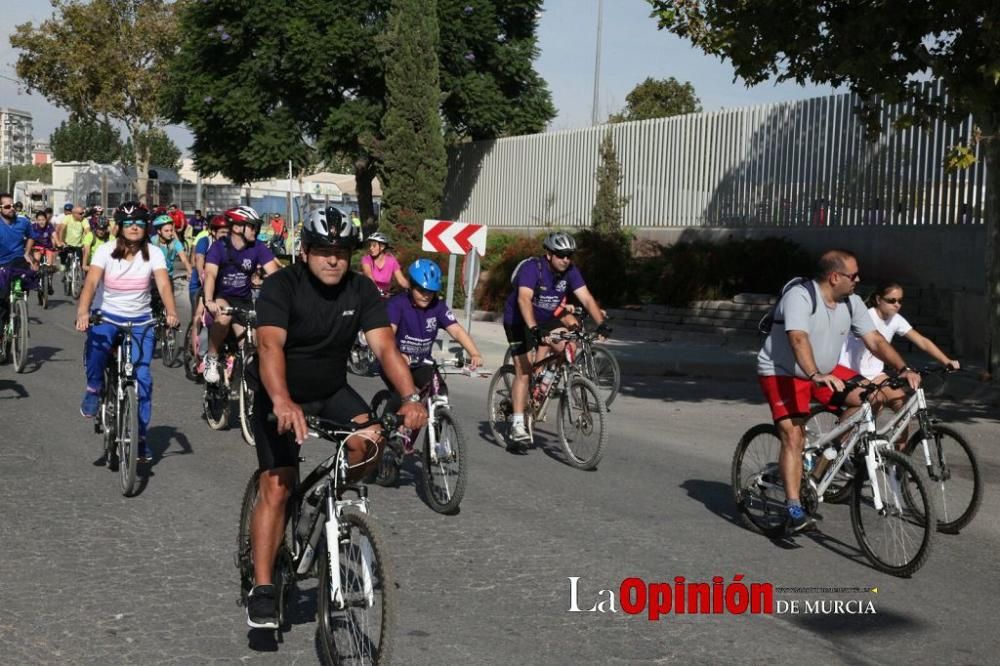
[757,250,920,532]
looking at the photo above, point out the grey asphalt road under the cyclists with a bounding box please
[0,292,1000,664]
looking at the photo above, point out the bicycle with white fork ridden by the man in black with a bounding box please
[236,413,398,664]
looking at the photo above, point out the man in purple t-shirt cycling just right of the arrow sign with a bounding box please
[503,231,611,452]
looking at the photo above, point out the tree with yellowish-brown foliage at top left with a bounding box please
[10,0,178,199]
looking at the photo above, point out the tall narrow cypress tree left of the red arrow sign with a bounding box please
[379,0,448,240]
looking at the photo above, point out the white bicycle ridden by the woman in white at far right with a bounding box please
[806,367,983,534]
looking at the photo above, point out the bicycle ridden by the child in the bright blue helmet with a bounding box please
[372,357,478,514]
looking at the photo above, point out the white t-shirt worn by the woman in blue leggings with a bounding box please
[90,243,167,318]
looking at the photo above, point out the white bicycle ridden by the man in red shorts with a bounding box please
[732,378,935,576]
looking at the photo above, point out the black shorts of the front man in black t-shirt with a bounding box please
[253,384,371,470]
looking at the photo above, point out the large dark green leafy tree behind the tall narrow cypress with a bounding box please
[166,0,555,225]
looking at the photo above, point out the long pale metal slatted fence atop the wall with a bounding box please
[444,83,985,228]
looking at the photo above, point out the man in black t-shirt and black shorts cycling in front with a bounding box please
[247,208,427,628]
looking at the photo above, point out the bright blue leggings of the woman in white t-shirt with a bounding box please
[84,315,155,440]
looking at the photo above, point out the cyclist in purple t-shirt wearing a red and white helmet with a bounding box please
[203,206,281,382]
